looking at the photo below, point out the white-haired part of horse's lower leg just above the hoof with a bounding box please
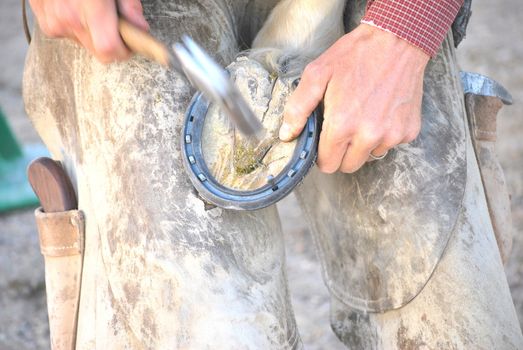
[249,0,346,74]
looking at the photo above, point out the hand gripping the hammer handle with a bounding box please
[29,0,149,63]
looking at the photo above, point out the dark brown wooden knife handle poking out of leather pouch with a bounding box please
[27,157,78,213]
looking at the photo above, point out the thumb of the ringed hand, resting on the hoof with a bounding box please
[279,61,330,141]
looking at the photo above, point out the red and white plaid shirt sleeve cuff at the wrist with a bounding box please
[361,0,464,57]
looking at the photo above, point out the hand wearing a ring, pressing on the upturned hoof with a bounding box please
[280,24,430,173]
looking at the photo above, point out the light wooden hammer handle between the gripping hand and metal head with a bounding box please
[118,17,171,67]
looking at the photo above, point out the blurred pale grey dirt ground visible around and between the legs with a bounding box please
[0,0,523,350]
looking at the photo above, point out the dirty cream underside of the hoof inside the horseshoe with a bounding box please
[202,57,296,191]
